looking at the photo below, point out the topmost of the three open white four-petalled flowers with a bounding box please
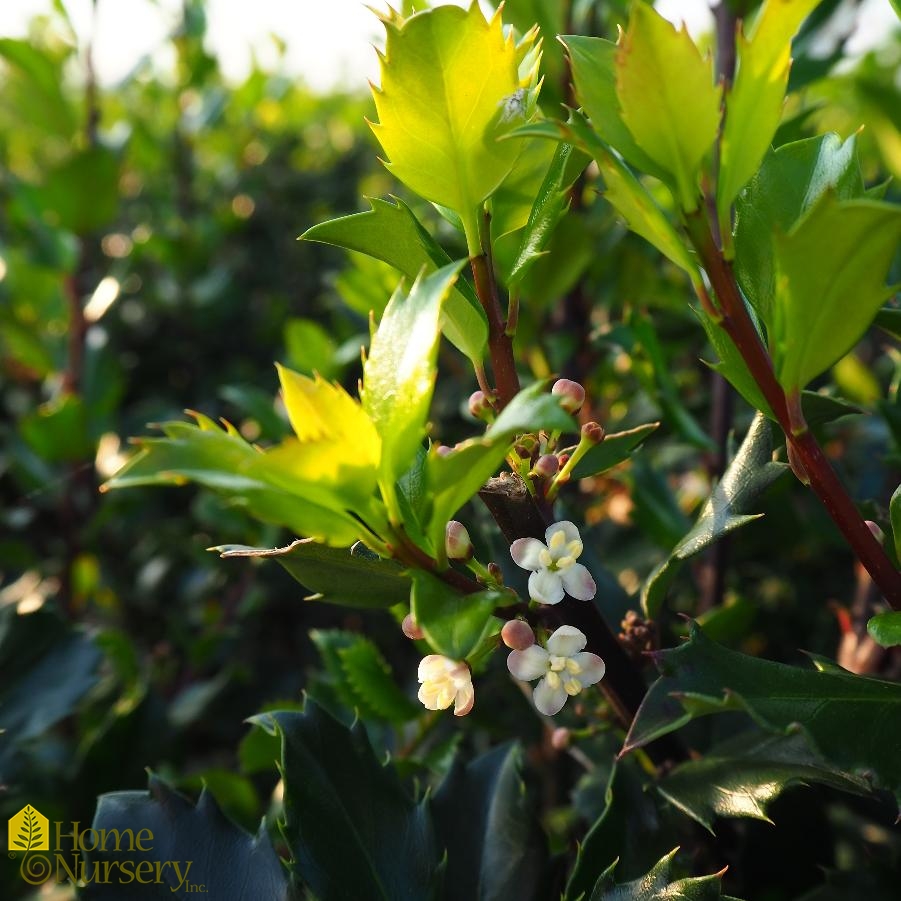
[510,520,597,604]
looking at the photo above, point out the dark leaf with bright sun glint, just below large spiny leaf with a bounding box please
[657,733,870,832]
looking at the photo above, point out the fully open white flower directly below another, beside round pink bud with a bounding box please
[507,626,607,716]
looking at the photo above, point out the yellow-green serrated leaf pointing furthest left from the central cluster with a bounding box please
[103,413,368,547]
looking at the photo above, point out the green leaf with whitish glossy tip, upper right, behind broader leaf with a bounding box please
[735,132,864,330]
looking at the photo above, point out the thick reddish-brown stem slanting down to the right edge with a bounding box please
[687,214,901,610]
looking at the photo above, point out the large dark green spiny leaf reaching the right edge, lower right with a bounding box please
[623,623,901,797]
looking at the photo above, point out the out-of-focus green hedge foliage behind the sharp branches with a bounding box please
[0,0,901,899]
